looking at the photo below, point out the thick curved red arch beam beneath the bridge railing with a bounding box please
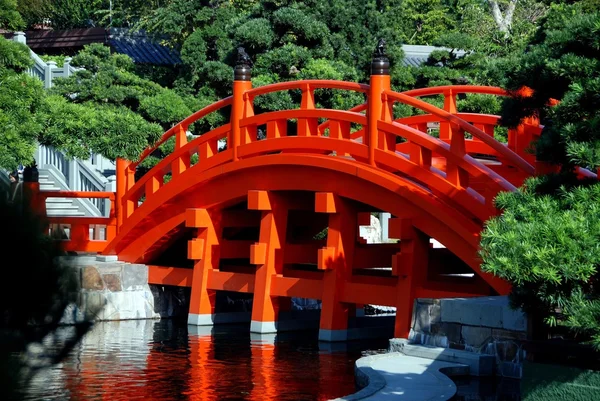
[105,154,496,282]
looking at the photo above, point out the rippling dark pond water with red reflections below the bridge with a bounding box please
[28,320,387,401]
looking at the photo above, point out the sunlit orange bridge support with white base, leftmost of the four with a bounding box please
[185,209,221,326]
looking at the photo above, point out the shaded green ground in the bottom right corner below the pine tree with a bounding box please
[521,363,600,401]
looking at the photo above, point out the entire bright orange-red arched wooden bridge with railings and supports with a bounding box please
[32,48,591,340]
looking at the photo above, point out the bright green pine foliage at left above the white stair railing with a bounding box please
[0,38,199,169]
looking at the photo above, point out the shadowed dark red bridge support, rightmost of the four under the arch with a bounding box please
[389,218,430,338]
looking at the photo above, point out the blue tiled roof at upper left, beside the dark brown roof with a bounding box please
[108,28,181,65]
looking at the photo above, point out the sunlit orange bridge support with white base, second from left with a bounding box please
[248,191,289,333]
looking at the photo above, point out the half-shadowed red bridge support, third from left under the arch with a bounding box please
[315,192,358,341]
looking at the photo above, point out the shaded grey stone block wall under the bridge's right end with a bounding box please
[409,297,527,378]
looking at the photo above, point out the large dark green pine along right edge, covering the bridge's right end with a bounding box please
[481,4,600,348]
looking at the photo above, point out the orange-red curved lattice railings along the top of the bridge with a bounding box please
[117,80,539,231]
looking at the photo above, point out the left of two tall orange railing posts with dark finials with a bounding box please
[232,47,252,161]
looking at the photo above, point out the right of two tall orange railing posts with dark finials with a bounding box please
[364,39,391,166]
